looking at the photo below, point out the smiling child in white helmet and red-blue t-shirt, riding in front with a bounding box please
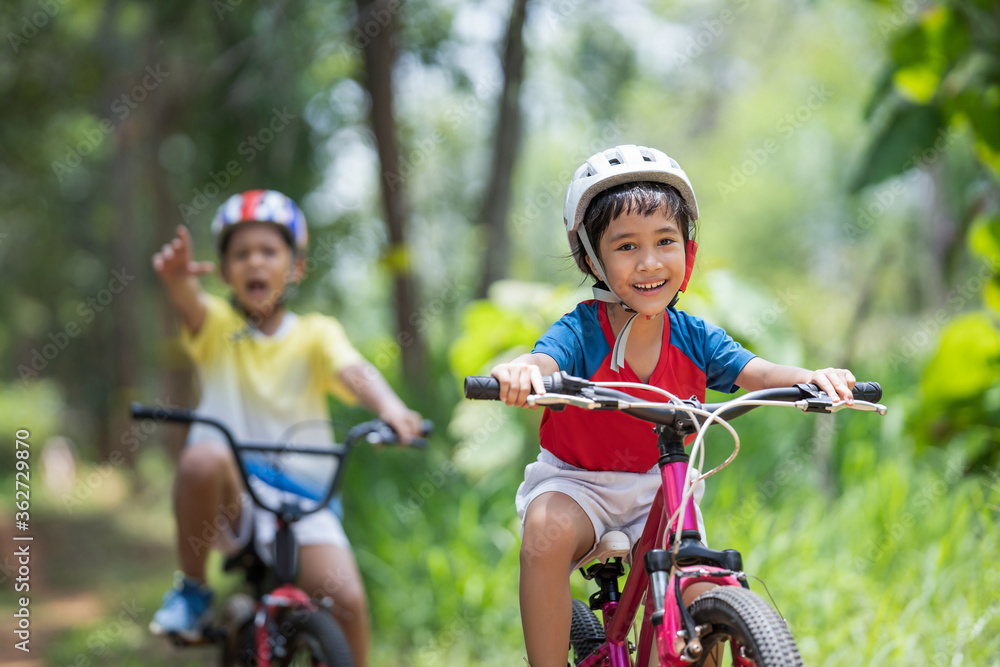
[491,145,855,667]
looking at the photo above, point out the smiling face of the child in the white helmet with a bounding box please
[587,209,685,316]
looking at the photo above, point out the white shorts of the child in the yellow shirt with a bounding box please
[210,484,351,565]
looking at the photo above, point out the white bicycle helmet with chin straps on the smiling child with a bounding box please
[563,144,698,371]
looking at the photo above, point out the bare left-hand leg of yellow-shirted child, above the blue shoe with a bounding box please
[174,441,243,583]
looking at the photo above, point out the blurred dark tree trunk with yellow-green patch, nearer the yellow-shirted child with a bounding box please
[357,0,425,386]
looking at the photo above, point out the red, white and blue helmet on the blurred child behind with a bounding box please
[212,190,309,252]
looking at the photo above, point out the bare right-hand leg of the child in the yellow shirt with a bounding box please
[299,544,369,667]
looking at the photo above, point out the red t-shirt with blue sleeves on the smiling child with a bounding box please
[532,300,756,472]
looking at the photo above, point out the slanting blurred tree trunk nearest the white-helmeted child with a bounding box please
[477,0,528,298]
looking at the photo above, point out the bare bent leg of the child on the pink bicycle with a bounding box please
[520,492,596,667]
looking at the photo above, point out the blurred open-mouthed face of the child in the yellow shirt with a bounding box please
[221,222,302,321]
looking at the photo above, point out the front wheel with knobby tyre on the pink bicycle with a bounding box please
[690,586,802,667]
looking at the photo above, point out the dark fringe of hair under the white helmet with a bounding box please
[574,181,691,278]
